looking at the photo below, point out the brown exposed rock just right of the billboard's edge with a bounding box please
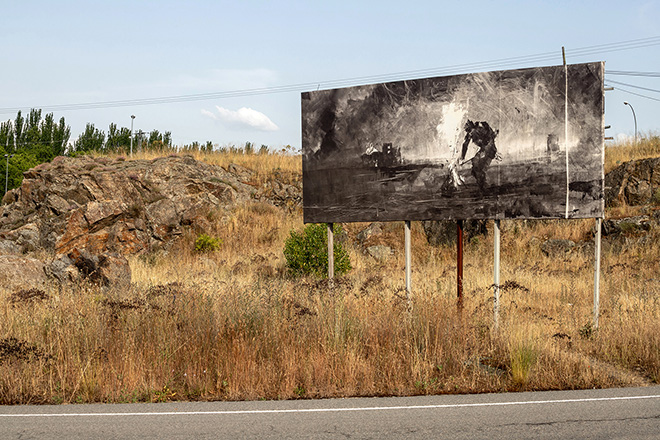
[605,157,660,206]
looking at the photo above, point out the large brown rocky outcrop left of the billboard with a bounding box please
[0,155,301,256]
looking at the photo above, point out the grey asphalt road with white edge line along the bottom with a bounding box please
[0,386,660,440]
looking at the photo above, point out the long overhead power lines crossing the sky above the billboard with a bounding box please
[0,36,660,114]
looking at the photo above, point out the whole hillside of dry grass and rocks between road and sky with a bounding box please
[0,137,660,403]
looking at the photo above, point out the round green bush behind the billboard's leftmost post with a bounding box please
[284,224,351,278]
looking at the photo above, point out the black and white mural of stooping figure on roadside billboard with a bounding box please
[302,63,604,223]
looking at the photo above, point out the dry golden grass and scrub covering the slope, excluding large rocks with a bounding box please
[0,136,660,404]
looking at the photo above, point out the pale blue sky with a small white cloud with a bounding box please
[0,0,660,149]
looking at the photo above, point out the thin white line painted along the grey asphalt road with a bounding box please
[0,394,660,417]
